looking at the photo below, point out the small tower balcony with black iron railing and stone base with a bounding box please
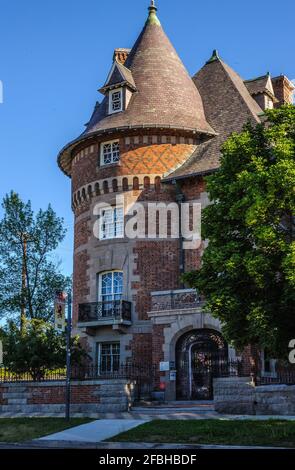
[78,300,131,329]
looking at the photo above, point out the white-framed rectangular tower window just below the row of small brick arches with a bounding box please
[99,206,124,240]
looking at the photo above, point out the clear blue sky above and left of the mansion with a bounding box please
[0,0,295,274]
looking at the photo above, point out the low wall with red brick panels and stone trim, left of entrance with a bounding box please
[0,379,135,414]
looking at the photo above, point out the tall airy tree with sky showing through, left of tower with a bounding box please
[0,192,70,324]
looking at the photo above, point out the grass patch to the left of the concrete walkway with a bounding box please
[0,418,92,442]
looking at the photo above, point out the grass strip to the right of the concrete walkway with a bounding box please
[108,419,295,447]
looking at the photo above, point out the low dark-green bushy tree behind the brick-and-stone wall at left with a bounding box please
[0,319,88,380]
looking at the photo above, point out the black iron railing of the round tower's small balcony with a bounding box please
[78,300,131,323]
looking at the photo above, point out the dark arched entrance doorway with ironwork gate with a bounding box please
[175,329,228,400]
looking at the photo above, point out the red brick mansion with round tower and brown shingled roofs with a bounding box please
[58,2,294,400]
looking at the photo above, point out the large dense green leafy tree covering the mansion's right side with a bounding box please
[185,105,295,357]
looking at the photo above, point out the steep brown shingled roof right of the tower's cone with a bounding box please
[165,51,263,181]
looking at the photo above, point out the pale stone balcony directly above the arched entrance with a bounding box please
[151,289,201,313]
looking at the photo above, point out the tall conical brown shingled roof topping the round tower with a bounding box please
[84,7,214,135]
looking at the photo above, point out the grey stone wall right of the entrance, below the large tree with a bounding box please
[213,377,295,415]
